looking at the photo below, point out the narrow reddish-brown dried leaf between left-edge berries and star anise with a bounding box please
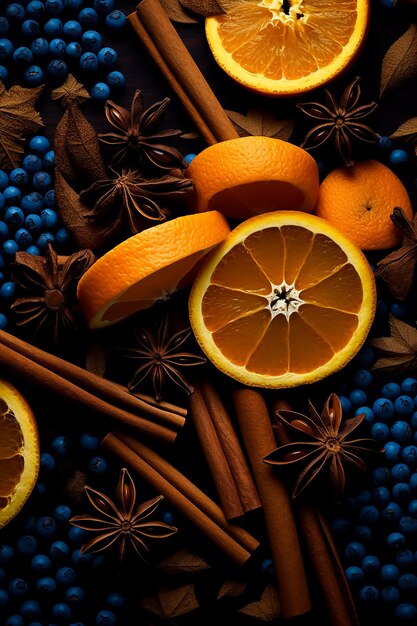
[55,168,106,250]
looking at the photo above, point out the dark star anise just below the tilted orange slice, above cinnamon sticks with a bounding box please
[122,313,206,402]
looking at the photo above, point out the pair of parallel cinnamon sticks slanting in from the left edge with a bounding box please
[0,330,187,443]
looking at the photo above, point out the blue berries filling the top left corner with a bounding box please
[0,0,126,97]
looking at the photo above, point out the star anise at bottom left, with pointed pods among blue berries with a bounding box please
[70,468,177,561]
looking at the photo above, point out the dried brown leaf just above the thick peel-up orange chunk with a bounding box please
[226,107,294,141]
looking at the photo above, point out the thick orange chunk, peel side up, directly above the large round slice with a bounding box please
[186,136,319,219]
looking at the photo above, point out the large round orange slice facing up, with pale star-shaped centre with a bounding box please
[189,211,376,388]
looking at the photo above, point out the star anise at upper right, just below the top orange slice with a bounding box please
[297,77,378,165]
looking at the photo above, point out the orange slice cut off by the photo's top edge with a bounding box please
[206,0,371,95]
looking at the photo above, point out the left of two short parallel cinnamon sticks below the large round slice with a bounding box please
[190,387,244,519]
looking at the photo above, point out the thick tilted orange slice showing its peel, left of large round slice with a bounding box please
[77,211,230,328]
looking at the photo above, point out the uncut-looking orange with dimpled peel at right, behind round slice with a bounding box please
[315,160,413,250]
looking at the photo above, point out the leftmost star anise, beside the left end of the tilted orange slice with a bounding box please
[10,243,95,346]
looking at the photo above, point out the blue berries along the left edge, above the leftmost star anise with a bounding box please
[0,135,69,328]
